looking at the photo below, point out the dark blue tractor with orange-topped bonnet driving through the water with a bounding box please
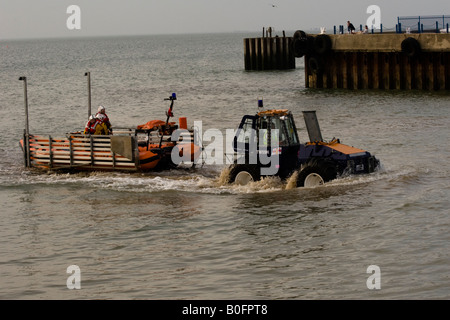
[228,109,379,187]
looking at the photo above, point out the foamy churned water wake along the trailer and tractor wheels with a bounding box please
[1,162,420,194]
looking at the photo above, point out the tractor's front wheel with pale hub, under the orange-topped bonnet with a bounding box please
[297,161,337,188]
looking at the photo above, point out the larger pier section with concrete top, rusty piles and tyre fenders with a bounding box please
[304,33,450,90]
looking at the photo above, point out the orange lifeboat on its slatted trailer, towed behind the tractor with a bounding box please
[20,94,202,171]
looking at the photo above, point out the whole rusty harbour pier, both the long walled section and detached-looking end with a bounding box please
[244,31,450,90]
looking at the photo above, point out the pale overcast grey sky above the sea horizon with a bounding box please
[0,0,450,39]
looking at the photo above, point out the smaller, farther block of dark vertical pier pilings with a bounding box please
[244,36,295,70]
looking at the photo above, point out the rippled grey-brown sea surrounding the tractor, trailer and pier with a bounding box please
[0,33,450,300]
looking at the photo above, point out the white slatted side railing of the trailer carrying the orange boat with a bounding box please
[22,129,194,171]
